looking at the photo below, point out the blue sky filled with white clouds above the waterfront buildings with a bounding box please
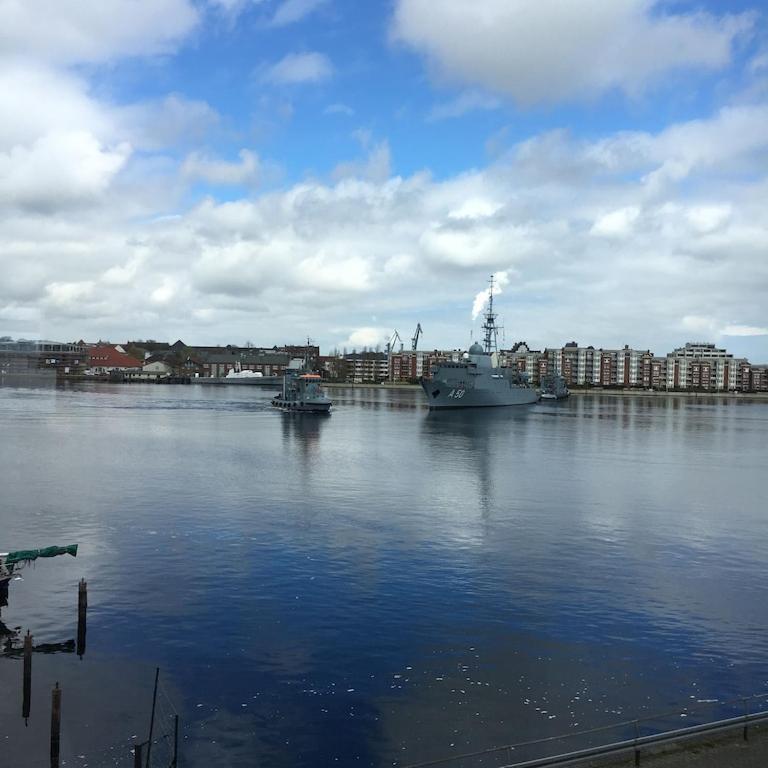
[0,0,768,362]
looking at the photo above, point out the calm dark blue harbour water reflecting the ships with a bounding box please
[0,385,768,767]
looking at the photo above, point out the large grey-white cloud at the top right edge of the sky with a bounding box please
[392,0,753,105]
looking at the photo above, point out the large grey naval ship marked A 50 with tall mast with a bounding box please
[421,278,539,410]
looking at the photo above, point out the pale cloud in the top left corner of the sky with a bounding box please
[0,0,199,64]
